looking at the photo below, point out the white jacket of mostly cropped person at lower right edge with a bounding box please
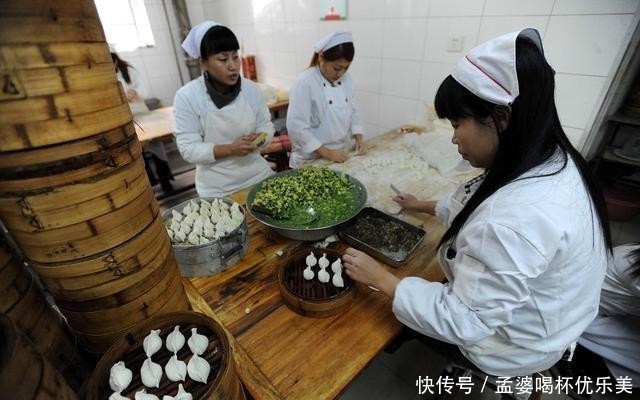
[578,244,640,387]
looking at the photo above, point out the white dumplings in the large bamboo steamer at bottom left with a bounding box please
[109,325,215,400]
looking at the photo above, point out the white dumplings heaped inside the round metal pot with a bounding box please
[166,199,244,246]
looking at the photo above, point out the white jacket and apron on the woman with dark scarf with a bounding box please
[173,76,274,197]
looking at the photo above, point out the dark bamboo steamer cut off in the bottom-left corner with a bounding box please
[0,315,78,400]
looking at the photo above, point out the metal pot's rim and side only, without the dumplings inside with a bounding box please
[162,197,249,276]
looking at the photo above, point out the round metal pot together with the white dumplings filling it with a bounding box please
[162,198,249,276]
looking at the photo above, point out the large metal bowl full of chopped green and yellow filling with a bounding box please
[247,166,367,241]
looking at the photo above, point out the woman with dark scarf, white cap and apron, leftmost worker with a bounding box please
[173,21,274,197]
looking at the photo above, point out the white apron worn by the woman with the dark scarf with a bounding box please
[196,92,273,197]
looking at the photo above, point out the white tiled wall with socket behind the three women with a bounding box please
[182,0,640,147]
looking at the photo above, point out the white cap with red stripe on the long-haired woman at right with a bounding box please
[451,28,544,105]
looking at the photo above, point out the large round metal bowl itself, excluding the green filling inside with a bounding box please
[247,169,367,241]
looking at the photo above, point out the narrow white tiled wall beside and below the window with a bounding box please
[114,0,187,106]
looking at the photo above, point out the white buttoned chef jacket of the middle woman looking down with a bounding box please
[287,66,364,168]
